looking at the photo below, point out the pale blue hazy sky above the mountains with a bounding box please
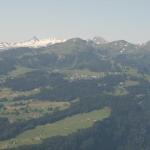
[0,0,150,43]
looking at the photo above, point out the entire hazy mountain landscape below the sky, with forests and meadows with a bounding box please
[0,37,150,150]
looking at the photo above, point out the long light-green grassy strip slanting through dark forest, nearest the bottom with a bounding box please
[0,107,111,149]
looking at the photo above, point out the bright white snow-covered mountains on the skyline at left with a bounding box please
[0,36,66,49]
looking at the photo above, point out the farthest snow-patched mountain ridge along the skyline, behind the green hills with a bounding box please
[0,36,150,53]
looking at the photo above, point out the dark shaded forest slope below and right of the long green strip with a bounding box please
[12,93,150,150]
